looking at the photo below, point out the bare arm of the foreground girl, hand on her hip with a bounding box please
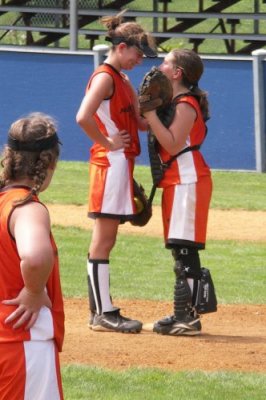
[3,202,54,329]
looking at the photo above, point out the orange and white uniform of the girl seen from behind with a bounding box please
[0,186,64,400]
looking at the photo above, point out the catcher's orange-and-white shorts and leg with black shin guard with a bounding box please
[155,182,216,335]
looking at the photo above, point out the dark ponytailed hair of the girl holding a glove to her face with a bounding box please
[171,49,210,120]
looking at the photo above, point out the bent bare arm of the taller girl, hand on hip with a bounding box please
[76,73,130,150]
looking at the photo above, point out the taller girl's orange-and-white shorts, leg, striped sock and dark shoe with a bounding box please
[88,158,142,332]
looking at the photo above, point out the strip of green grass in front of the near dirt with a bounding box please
[63,366,266,400]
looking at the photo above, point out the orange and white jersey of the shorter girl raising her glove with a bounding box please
[159,96,210,188]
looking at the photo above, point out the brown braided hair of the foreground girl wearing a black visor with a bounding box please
[0,113,60,204]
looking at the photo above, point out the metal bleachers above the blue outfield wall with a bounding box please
[0,0,266,55]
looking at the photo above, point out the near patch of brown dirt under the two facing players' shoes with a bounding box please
[61,299,266,372]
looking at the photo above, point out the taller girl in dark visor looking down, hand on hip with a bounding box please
[76,12,156,333]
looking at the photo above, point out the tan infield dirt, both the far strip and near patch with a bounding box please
[48,205,266,373]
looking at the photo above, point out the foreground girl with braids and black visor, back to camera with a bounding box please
[0,113,64,400]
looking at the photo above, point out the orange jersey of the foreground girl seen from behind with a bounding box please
[0,186,64,351]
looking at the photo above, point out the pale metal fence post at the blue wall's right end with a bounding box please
[252,49,266,172]
